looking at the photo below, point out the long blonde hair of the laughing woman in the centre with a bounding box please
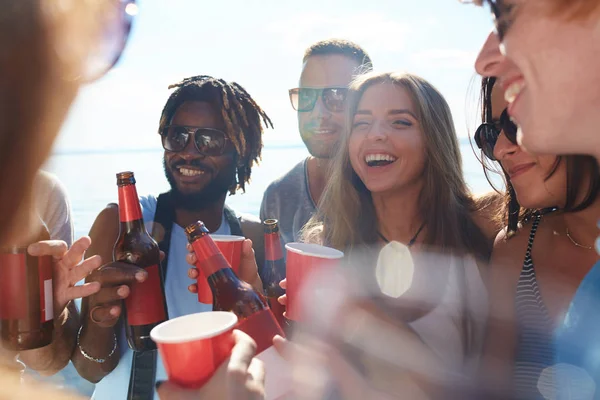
[304,72,489,258]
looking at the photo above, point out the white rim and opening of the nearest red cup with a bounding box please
[150,311,238,344]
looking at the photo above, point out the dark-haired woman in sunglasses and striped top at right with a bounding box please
[475,77,600,399]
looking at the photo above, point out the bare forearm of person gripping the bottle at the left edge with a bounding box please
[19,302,79,376]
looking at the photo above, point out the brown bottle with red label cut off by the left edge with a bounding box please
[0,219,54,351]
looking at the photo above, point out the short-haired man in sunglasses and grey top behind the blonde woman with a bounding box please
[260,39,372,244]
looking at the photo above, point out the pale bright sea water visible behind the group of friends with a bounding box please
[45,141,491,238]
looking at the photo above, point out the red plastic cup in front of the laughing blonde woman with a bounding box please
[285,243,344,321]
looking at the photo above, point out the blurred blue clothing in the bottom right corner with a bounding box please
[556,220,600,399]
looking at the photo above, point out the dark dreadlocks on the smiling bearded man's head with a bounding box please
[158,75,273,195]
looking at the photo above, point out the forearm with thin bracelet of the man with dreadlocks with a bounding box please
[71,302,120,383]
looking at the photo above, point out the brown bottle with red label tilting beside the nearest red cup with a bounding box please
[185,221,285,354]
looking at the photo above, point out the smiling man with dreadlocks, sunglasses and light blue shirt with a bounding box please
[73,75,272,399]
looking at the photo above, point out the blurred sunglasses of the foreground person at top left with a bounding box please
[81,0,138,82]
